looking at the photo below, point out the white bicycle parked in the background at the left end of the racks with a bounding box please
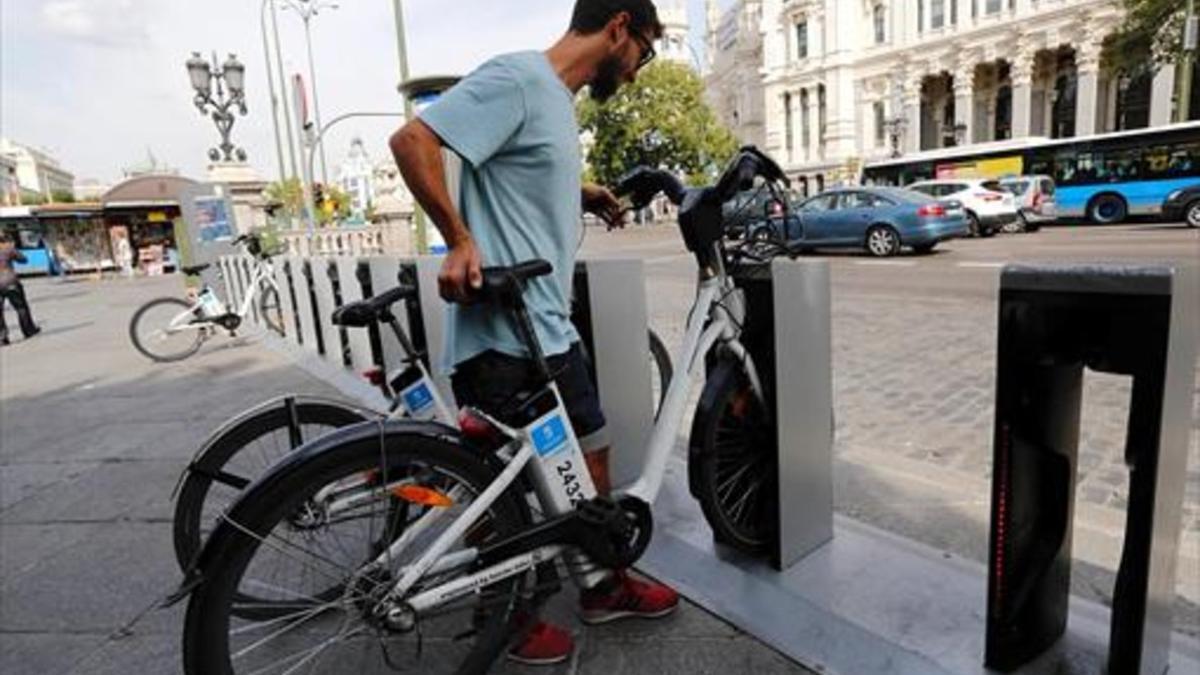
[130,234,284,363]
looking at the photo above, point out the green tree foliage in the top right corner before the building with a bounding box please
[1104,0,1187,73]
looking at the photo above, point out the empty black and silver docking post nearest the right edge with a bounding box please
[984,267,1198,675]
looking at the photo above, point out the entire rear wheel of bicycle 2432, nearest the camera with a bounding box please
[184,432,529,675]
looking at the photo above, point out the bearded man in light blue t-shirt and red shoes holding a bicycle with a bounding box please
[391,0,678,664]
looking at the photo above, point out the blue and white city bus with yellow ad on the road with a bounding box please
[863,121,1200,225]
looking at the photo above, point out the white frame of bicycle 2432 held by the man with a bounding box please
[370,246,766,615]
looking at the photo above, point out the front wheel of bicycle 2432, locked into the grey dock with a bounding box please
[689,368,779,554]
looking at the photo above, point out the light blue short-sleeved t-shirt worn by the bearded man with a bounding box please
[420,52,583,369]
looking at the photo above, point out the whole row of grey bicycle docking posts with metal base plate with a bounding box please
[226,251,1200,675]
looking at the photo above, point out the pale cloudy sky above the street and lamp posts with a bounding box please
[0,0,733,183]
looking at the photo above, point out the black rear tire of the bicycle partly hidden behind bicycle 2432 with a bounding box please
[173,401,366,572]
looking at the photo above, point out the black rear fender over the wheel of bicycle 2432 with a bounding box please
[163,419,511,607]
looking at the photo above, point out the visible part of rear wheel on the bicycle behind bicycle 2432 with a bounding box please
[174,400,366,572]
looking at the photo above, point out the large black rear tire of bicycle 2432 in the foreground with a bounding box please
[182,431,532,675]
